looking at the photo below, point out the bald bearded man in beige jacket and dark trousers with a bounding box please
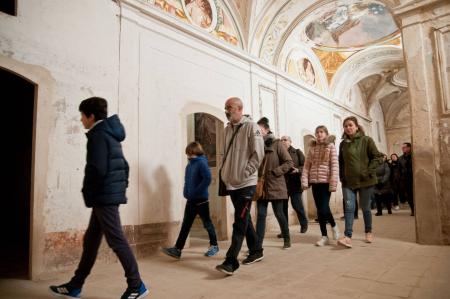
[216,97,264,275]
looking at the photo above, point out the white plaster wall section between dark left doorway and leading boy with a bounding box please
[0,0,119,232]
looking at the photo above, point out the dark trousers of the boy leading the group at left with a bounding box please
[69,205,141,288]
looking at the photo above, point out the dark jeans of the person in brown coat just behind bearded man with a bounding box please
[256,200,289,249]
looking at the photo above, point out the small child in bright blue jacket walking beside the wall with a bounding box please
[162,141,219,259]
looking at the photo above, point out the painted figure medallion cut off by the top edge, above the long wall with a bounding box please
[181,0,217,31]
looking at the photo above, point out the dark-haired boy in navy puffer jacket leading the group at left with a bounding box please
[50,97,149,299]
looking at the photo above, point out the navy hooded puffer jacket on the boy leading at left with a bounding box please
[82,115,129,207]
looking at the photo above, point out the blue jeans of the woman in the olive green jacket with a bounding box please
[342,186,373,238]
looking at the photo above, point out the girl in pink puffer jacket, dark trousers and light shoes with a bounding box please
[302,126,339,246]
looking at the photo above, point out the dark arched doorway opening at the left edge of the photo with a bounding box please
[0,68,36,278]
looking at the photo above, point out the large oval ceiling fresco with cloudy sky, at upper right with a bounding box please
[301,0,398,50]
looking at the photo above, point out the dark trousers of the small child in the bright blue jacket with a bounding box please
[175,199,217,250]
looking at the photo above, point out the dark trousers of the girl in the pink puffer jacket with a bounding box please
[311,184,336,236]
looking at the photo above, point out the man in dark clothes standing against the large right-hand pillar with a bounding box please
[398,142,414,216]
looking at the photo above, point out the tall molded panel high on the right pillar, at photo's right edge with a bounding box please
[433,25,450,115]
